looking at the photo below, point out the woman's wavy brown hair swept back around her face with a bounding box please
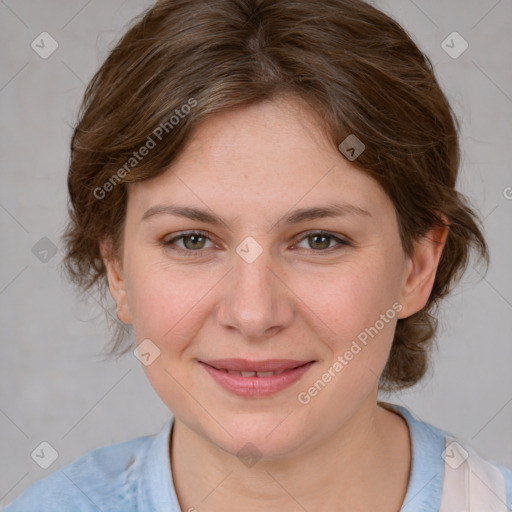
[63,0,489,391]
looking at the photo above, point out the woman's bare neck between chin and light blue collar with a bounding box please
[171,396,411,512]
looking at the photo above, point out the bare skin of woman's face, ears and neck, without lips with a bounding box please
[101,98,447,512]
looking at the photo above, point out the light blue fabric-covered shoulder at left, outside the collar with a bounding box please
[4,436,155,512]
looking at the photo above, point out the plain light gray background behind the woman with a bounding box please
[0,0,512,505]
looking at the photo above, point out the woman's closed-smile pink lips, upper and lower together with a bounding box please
[199,359,315,398]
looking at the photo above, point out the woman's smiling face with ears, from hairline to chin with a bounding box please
[103,101,444,457]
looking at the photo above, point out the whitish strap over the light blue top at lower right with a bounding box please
[439,436,507,512]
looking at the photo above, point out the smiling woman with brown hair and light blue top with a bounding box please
[6,0,512,512]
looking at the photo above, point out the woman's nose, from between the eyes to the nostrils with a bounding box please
[218,243,295,341]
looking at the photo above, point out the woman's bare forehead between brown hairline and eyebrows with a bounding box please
[129,99,385,224]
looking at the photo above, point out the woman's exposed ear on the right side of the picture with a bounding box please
[398,215,449,318]
